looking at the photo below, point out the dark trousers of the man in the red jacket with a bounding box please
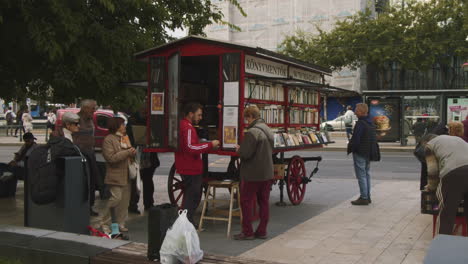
[181,175,203,224]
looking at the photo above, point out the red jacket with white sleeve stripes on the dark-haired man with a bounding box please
[175,118,213,175]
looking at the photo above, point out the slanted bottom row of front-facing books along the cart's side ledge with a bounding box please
[274,131,330,148]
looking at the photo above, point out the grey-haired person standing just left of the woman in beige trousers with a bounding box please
[72,99,104,216]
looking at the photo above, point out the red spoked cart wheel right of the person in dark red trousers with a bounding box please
[286,156,307,205]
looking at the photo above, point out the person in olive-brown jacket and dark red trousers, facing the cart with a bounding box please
[234,106,274,240]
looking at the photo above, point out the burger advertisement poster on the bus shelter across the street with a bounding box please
[368,98,400,142]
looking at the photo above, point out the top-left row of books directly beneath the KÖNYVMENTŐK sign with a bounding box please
[244,82,284,102]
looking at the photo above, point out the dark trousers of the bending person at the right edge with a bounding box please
[436,166,468,235]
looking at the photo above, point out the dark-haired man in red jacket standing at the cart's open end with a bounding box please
[175,103,219,224]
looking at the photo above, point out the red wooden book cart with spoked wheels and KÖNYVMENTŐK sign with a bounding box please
[135,36,331,205]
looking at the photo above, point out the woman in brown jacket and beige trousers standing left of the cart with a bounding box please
[98,117,136,233]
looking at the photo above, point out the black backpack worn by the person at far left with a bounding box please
[27,137,86,205]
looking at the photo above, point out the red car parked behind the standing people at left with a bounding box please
[55,108,128,148]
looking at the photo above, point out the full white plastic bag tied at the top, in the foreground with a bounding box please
[159,210,203,264]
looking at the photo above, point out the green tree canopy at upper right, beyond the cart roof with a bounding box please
[279,0,468,76]
